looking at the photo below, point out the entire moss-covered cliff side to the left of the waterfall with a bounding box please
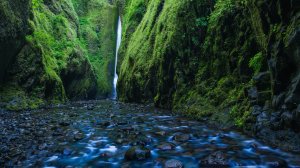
[0,0,117,109]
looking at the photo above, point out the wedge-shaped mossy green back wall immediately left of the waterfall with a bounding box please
[73,0,118,96]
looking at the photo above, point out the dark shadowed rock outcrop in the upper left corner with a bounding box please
[0,0,30,82]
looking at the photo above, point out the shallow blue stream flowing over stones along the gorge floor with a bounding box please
[0,100,300,168]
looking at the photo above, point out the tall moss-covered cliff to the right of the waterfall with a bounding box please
[118,0,300,151]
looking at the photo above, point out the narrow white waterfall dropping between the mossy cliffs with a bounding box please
[112,16,122,100]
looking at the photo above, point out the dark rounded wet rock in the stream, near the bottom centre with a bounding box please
[125,146,151,160]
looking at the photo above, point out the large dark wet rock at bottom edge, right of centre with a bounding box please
[199,151,229,167]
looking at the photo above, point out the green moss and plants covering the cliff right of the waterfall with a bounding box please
[118,0,296,129]
